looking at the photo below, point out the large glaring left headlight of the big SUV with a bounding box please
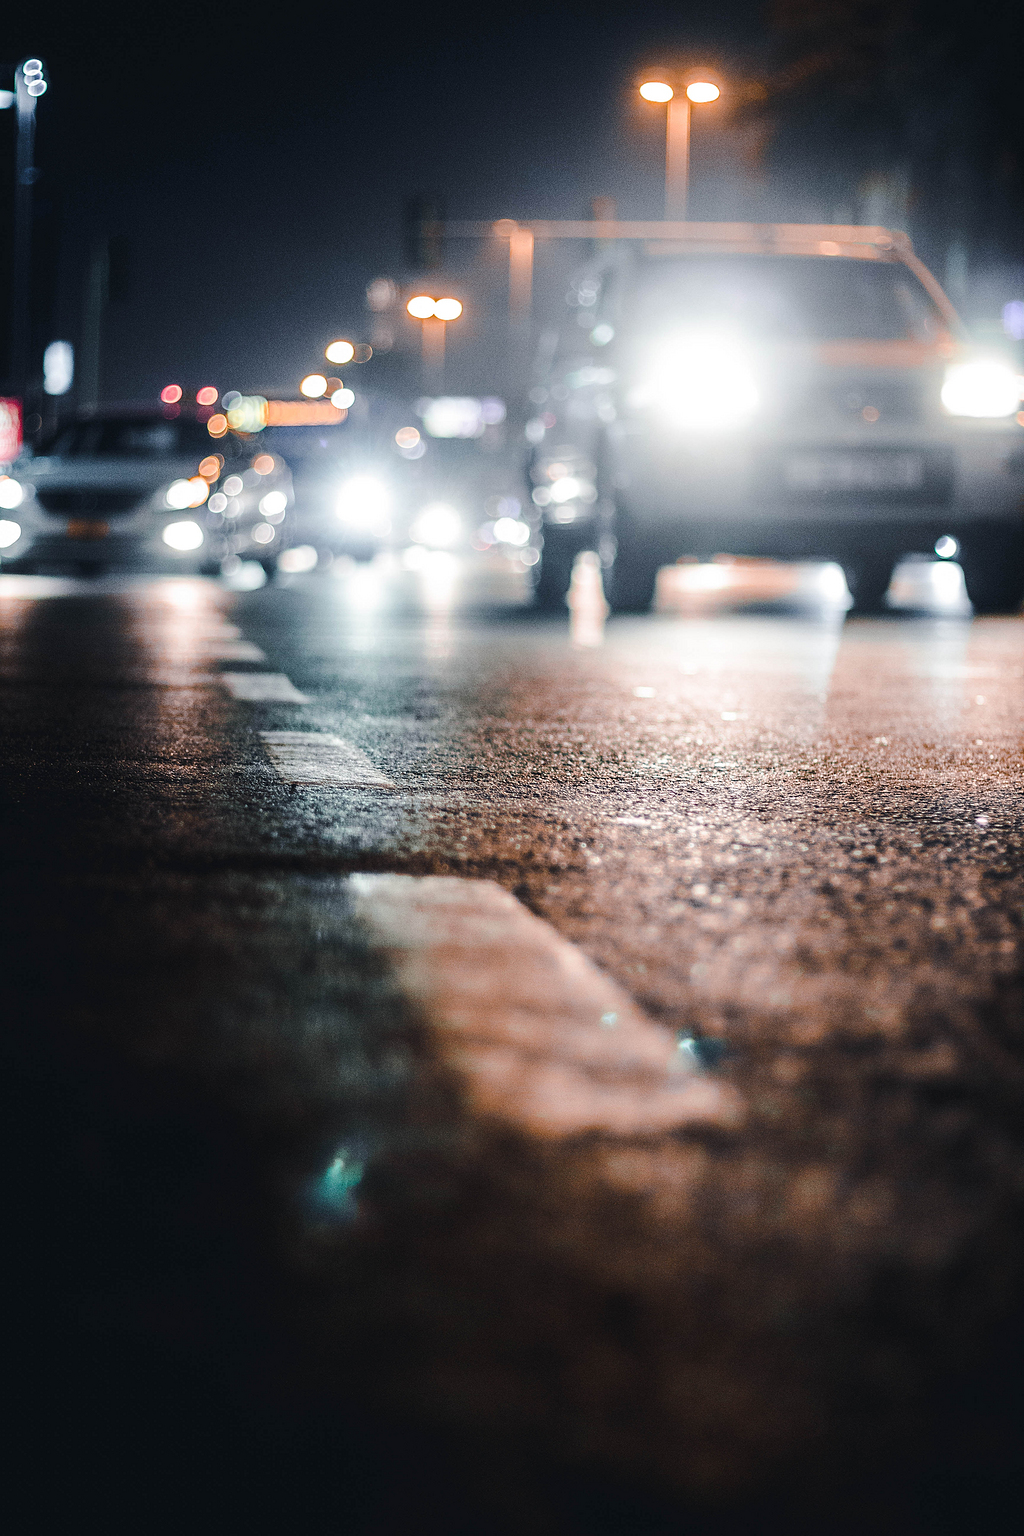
[629,336,760,432]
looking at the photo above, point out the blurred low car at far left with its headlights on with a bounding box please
[0,413,292,573]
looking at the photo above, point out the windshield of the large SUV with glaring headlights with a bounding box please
[623,255,949,341]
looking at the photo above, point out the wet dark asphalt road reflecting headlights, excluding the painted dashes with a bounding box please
[0,564,1024,1536]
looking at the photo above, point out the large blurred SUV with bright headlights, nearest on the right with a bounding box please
[527,223,1024,611]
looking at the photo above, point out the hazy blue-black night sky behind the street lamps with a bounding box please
[0,0,1019,399]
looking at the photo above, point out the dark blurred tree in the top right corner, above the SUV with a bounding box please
[763,0,1024,279]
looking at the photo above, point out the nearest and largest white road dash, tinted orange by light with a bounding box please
[345,874,743,1137]
